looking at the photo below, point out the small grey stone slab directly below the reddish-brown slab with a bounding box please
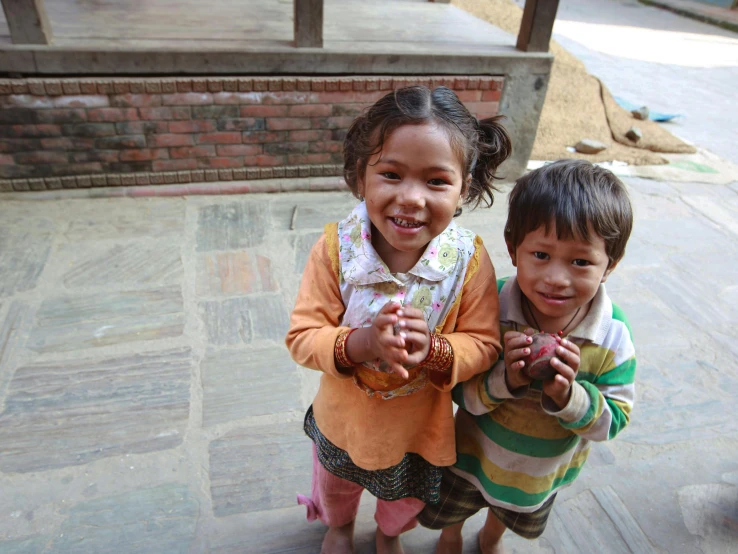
[200,294,289,345]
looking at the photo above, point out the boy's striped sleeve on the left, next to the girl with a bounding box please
[452,360,530,415]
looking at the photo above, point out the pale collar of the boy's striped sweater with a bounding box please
[500,277,612,345]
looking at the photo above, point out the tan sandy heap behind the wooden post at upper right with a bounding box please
[452,0,696,165]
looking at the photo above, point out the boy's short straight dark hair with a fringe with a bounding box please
[505,160,633,267]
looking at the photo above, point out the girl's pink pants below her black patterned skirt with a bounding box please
[297,445,425,537]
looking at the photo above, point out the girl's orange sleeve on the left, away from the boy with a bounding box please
[285,235,351,379]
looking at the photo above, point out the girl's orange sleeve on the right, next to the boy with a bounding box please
[433,244,502,391]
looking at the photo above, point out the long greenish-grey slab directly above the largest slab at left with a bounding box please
[28,287,184,352]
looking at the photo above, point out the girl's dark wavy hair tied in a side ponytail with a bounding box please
[343,85,512,210]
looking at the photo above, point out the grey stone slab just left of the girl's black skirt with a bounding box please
[209,421,312,517]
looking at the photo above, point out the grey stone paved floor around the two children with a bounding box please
[0,0,738,554]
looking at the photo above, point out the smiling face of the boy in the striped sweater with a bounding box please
[507,225,615,333]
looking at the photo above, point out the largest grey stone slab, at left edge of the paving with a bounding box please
[0,349,192,473]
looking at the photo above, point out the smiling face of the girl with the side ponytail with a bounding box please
[359,123,466,273]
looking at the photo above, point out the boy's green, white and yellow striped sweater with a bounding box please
[451,277,636,512]
